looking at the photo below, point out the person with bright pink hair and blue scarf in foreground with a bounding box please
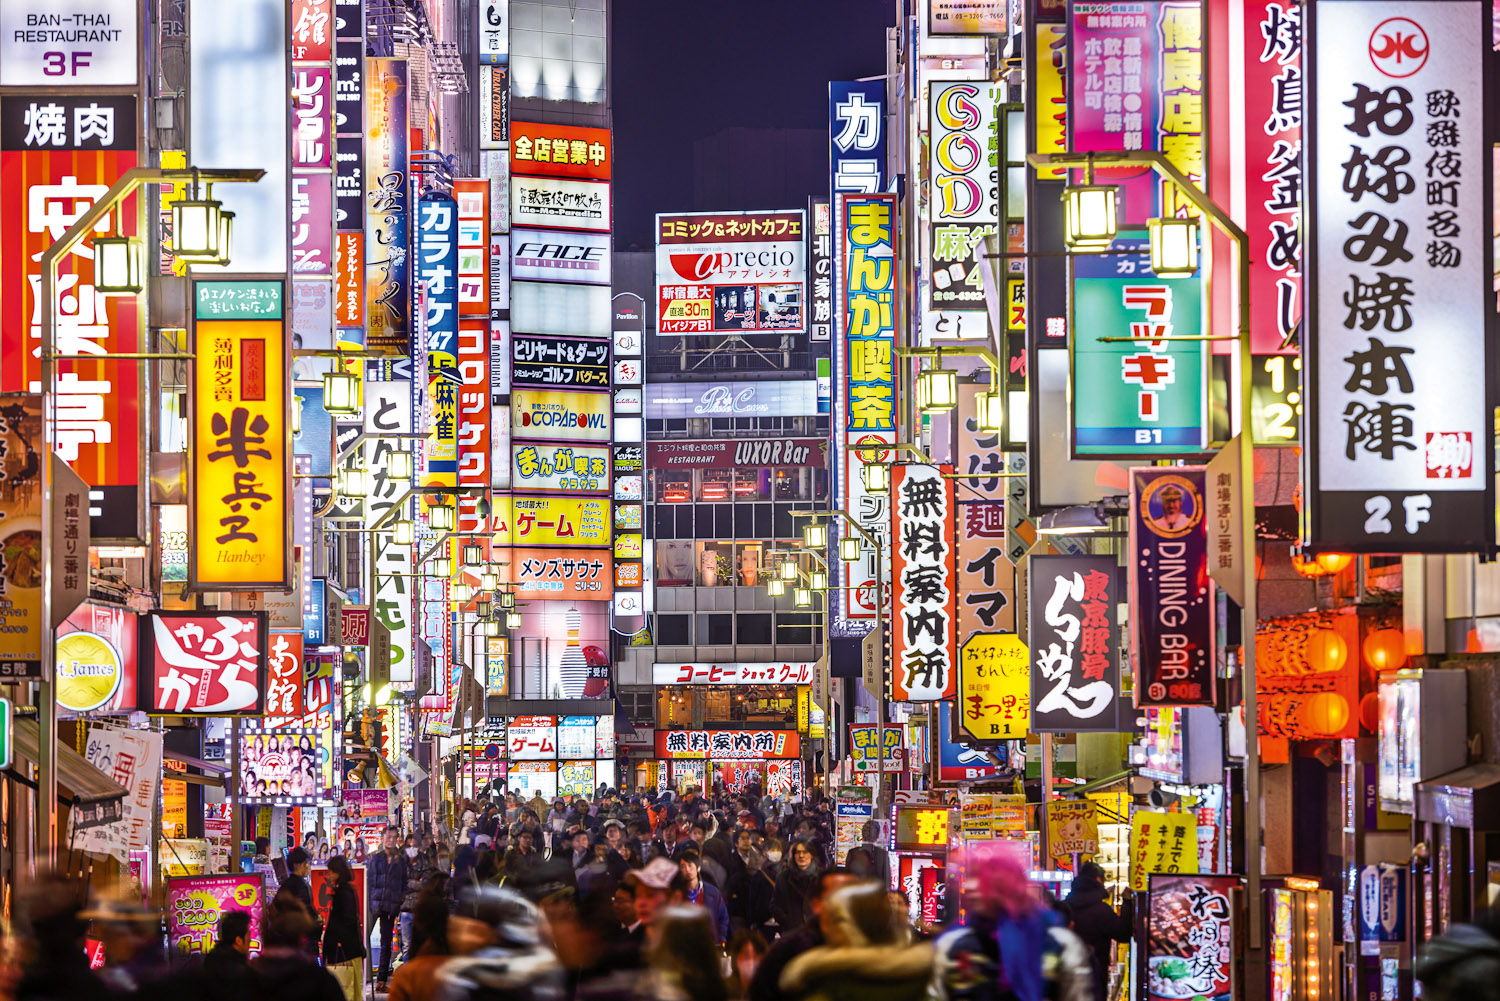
[933,840,1092,1001]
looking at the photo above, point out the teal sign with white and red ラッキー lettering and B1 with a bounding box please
[1070,234,1209,458]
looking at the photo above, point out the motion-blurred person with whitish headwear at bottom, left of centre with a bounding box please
[438,887,563,1001]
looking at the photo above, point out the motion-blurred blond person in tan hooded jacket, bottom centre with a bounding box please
[782,879,933,1001]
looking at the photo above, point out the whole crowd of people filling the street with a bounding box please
[9,789,1130,1001]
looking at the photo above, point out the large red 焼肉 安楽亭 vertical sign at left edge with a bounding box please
[0,96,146,540]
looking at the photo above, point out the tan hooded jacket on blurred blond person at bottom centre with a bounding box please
[782,894,933,1001]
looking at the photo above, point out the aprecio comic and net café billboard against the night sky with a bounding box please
[656,209,807,335]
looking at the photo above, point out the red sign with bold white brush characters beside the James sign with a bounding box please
[138,612,270,716]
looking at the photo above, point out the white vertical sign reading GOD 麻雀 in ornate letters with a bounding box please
[927,83,1001,309]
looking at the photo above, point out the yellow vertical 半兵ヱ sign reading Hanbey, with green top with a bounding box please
[188,281,291,591]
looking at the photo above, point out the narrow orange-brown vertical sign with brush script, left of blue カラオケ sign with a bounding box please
[365,59,411,354]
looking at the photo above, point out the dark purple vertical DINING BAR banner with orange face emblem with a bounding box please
[1128,465,1215,707]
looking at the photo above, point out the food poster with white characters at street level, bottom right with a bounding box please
[1146,875,1242,1001]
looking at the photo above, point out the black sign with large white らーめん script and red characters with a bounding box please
[1028,555,1121,734]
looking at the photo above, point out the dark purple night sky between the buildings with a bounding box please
[611,0,896,248]
